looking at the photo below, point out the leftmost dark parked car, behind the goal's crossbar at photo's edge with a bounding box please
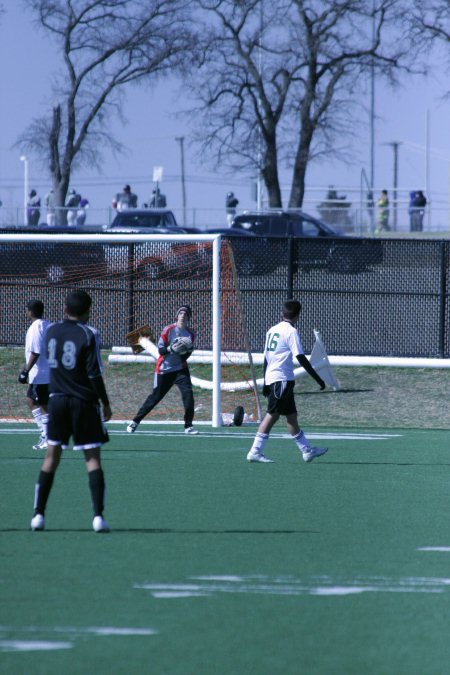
[0,225,105,283]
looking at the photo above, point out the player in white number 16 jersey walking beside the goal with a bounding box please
[247,300,328,463]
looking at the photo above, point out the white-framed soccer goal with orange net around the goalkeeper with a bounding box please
[0,234,262,426]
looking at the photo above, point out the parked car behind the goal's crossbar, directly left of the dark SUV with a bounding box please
[103,208,203,279]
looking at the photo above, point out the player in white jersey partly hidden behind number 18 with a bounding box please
[19,300,50,450]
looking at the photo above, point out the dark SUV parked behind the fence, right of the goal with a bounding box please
[225,210,383,273]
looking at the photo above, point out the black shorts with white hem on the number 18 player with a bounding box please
[47,394,109,450]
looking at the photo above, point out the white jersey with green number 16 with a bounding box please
[264,320,304,384]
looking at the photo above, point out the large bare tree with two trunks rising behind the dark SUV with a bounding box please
[185,0,418,208]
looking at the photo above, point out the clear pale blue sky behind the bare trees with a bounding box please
[0,0,450,227]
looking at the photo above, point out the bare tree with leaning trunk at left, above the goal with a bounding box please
[17,0,190,217]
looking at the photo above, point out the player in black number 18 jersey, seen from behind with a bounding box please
[31,291,112,532]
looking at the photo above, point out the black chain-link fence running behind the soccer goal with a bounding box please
[0,235,450,358]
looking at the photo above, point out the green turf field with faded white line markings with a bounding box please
[0,424,450,675]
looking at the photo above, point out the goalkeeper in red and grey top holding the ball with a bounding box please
[127,305,198,435]
